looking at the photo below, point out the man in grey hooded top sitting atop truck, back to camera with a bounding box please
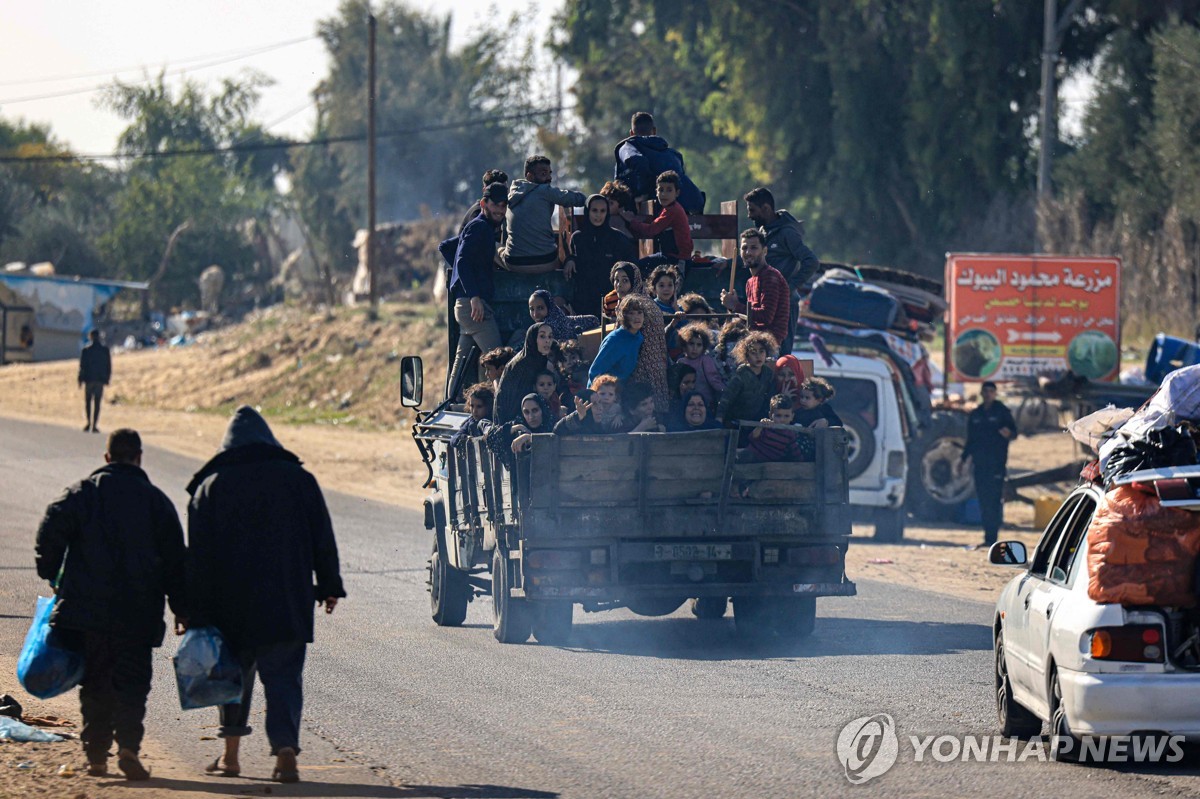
[500,155,587,275]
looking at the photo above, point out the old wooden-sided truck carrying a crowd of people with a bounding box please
[401,204,857,643]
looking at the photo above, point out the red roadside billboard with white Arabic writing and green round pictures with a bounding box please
[946,253,1121,382]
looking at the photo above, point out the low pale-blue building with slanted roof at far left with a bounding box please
[0,272,148,364]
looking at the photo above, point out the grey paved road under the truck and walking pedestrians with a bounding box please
[0,420,1200,799]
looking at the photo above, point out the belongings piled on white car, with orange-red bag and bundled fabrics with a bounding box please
[1070,366,1200,607]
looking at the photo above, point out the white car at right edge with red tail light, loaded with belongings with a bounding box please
[989,467,1200,759]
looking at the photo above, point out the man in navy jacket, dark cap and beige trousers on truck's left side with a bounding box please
[450,184,508,386]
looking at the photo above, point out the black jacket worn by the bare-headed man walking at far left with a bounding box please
[37,463,186,647]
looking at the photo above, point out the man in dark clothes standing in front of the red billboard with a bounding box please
[962,380,1016,546]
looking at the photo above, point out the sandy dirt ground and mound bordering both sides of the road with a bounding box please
[0,305,1073,601]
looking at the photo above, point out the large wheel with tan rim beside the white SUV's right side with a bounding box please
[905,410,974,522]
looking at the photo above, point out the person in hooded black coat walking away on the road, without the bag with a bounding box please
[187,405,346,782]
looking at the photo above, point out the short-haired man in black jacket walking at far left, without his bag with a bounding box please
[37,429,184,780]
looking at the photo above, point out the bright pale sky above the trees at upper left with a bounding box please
[0,0,563,154]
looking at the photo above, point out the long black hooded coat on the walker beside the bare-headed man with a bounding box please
[187,405,346,651]
